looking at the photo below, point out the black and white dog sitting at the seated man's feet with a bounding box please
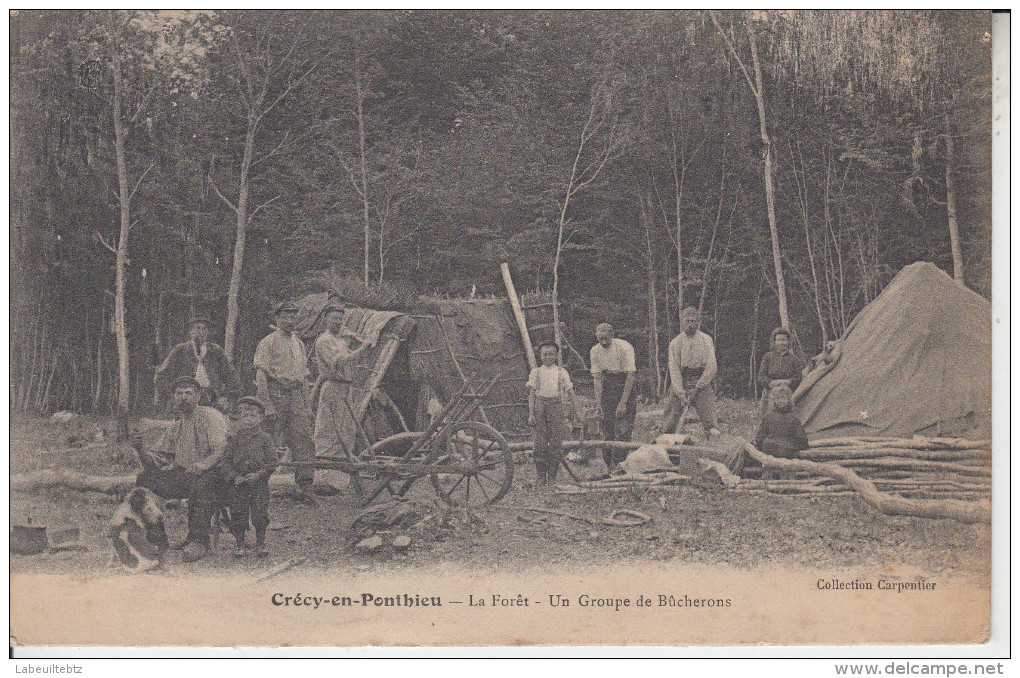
[108,487,170,573]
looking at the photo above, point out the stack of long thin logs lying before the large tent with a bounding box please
[740,436,991,501]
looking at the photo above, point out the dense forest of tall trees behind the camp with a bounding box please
[10,10,991,413]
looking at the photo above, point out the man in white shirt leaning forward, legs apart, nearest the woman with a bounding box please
[662,307,719,438]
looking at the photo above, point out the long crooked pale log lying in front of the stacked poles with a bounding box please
[744,442,991,523]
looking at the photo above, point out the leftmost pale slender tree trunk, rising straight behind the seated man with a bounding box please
[110,21,131,417]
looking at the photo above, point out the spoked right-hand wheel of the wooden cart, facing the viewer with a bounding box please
[429,421,513,507]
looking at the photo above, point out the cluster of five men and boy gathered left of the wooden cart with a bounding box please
[134,303,366,562]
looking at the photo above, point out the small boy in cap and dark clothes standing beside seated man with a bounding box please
[221,396,278,558]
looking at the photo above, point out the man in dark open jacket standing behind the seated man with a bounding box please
[156,313,241,410]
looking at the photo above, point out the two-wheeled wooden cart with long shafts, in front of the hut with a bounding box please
[282,375,514,508]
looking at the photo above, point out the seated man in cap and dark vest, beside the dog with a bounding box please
[133,376,228,563]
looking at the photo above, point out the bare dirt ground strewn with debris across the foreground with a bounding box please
[10,401,990,579]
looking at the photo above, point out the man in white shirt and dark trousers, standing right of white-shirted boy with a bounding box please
[590,322,638,468]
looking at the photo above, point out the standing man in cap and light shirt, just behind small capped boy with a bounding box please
[254,302,316,505]
